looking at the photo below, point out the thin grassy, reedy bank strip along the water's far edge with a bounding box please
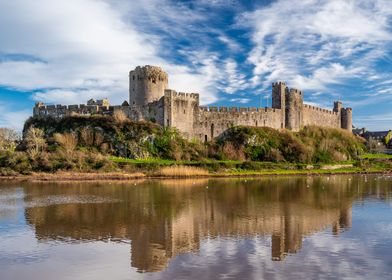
[0,166,392,182]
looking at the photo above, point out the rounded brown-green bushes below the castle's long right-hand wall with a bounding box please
[214,126,365,163]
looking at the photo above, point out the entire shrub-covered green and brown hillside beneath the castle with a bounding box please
[0,114,378,174]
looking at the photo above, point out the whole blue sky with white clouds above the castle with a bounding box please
[0,0,392,130]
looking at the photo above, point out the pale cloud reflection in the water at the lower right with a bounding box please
[152,225,392,279]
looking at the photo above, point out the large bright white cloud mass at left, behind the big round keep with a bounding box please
[0,0,222,107]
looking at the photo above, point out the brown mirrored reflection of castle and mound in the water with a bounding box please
[20,176,389,271]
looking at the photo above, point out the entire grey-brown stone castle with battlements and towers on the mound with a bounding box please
[33,65,352,141]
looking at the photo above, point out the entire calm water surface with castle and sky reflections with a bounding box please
[0,176,392,280]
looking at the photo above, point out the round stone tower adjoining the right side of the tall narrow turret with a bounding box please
[286,88,304,131]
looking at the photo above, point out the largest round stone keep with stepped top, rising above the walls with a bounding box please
[129,65,169,106]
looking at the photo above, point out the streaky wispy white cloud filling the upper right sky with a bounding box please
[238,0,392,90]
